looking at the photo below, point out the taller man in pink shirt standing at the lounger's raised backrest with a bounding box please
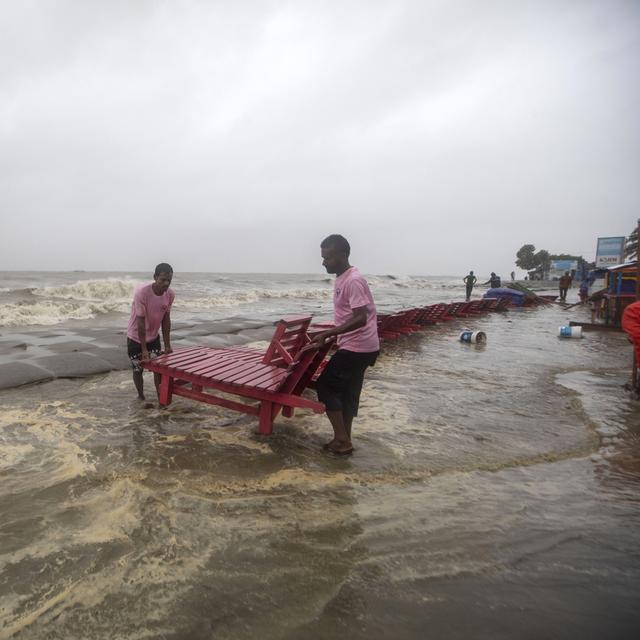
[313,234,380,455]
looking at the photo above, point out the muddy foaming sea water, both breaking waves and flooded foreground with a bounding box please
[0,273,640,640]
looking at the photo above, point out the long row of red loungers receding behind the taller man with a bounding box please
[378,298,509,340]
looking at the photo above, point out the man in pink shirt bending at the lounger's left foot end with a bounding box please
[127,262,175,400]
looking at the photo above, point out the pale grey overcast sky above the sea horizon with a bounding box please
[0,0,640,275]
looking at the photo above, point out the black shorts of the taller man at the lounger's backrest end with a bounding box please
[316,349,380,417]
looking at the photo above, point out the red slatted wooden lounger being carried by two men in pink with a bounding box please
[143,317,331,435]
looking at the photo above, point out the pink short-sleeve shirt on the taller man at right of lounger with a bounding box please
[333,267,380,353]
